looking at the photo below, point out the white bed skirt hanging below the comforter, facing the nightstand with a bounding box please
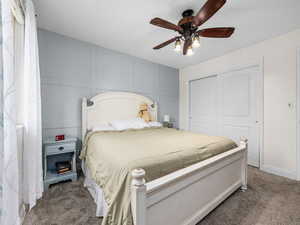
[81,160,108,217]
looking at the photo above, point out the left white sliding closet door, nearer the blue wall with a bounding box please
[189,76,218,135]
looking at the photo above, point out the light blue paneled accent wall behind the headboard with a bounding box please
[38,30,179,140]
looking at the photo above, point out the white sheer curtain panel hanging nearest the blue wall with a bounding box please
[23,0,43,208]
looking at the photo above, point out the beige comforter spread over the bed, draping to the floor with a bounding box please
[81,128,236,225]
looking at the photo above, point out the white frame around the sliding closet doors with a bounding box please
[187,60,264,168]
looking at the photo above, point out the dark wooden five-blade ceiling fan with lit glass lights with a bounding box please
[150,0,234,55]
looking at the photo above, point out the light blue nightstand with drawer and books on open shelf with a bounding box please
[43,138,77,190]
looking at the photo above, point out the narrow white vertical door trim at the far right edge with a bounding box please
[296,47,300,180]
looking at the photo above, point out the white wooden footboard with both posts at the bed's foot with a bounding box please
[131,139,247,225]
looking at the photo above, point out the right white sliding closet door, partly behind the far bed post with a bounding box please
[219,67,259,167]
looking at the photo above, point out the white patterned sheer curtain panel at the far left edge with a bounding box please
[1,0,21,225]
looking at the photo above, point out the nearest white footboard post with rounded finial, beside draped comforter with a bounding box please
[131,169,147,225]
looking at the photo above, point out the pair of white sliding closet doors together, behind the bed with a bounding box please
[190,67,260,167]
